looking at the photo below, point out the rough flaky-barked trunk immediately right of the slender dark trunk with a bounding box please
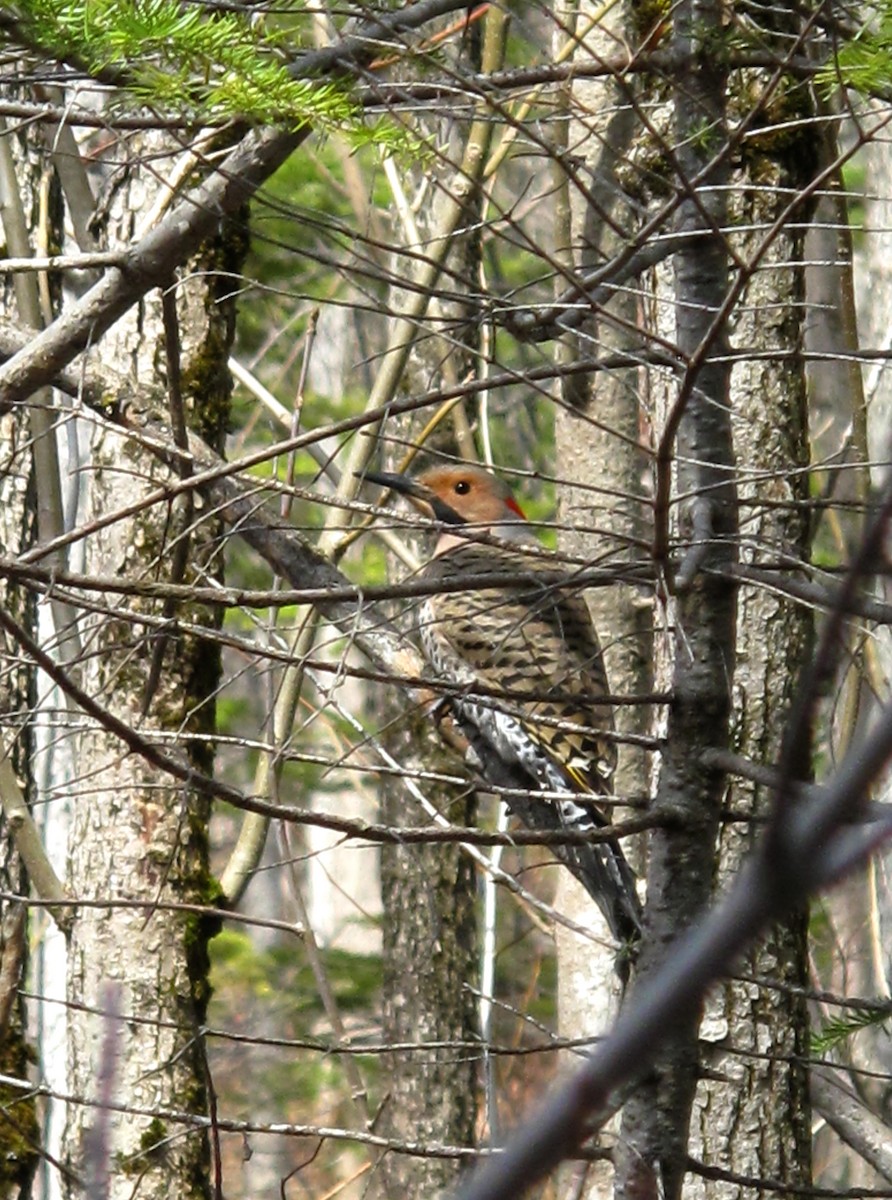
[687,148,812,1200]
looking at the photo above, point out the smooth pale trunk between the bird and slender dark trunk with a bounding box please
[555,5,653,1198]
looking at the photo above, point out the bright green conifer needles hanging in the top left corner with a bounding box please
[13,0,407,150]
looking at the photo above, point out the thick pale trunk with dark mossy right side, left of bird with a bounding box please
[55,129,241,1198]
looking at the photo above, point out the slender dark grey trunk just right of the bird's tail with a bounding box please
[617,0,737,1185]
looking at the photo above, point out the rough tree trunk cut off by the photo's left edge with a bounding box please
[0,100,66,1198]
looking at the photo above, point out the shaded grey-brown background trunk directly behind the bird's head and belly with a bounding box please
[381,13,497,1180]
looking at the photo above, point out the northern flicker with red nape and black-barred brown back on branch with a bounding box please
[366,464,641,946]
